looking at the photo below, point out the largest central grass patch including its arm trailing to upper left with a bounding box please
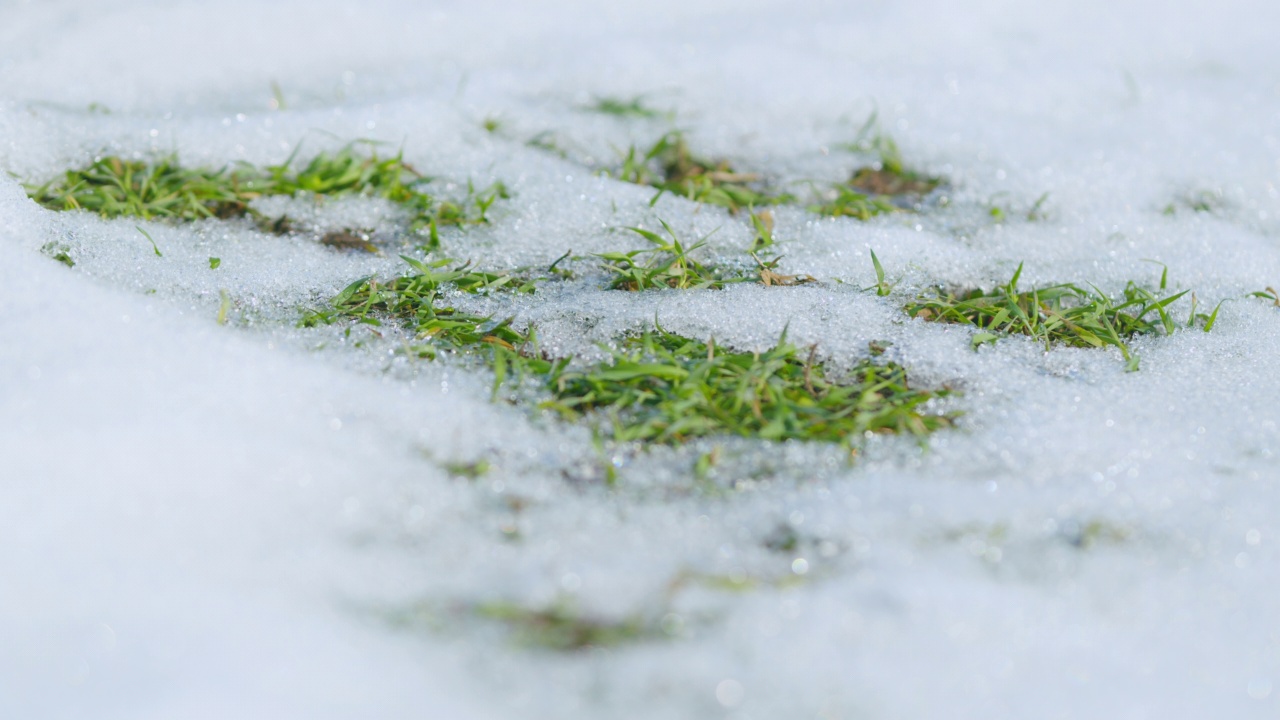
[300,253,954,450]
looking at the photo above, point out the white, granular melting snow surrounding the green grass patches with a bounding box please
[0,0,1280,719]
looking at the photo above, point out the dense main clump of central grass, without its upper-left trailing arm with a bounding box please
[544,328,952,448]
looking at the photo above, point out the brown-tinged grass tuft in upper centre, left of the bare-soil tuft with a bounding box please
[613,131,792,213]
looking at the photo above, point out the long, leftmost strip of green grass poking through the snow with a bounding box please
[27,143,508,246]
